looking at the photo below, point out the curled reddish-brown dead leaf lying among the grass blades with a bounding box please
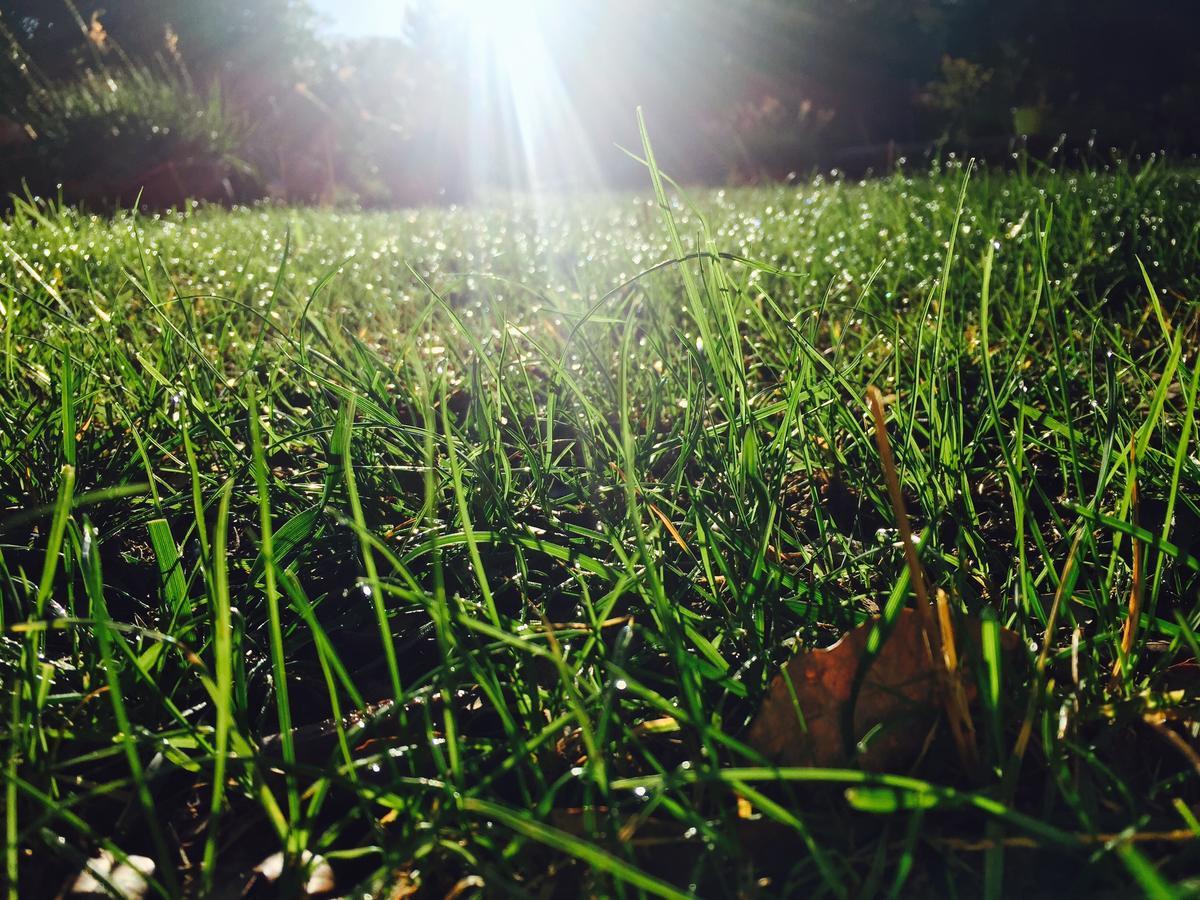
[749,610,1018,770]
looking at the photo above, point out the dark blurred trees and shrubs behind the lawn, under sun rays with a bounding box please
[0,0,1200,208]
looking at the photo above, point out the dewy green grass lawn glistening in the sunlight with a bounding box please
[0,146,1200,898]
